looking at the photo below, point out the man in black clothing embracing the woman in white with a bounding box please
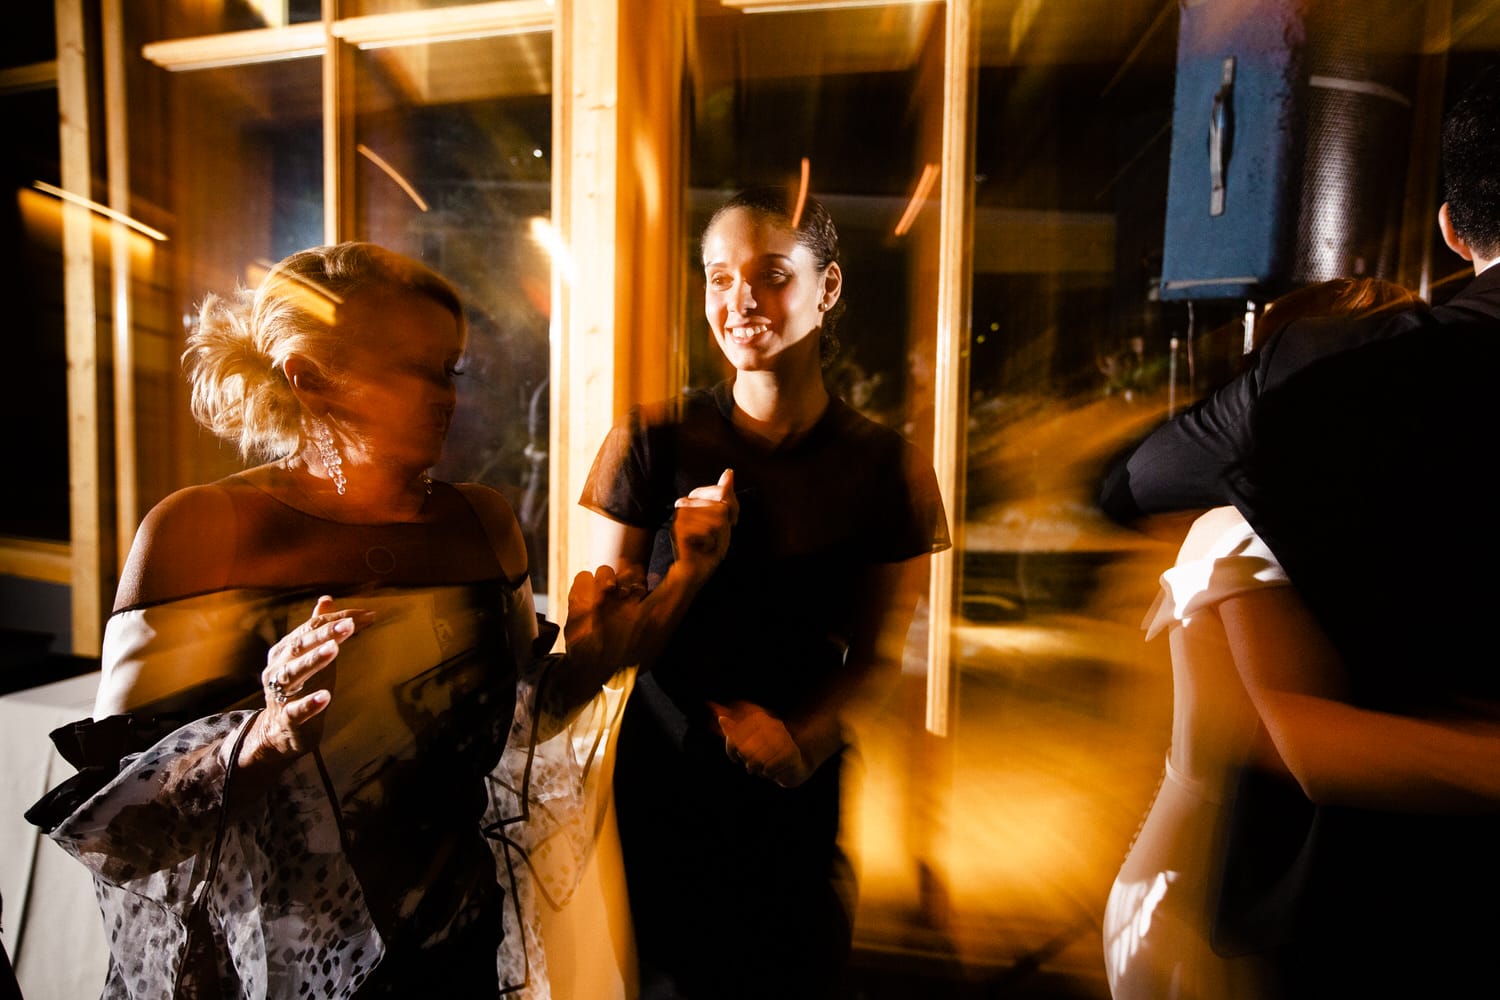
[1101,67,1500,997]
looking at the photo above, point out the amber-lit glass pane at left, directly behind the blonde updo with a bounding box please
[126,34,324,503]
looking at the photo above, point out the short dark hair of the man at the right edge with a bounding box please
[1443,63,1500,258]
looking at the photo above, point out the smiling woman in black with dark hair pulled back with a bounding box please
[582,187,948,1000]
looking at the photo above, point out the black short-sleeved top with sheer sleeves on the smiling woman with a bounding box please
[581,382,950,720]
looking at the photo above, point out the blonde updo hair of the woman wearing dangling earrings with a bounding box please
[182,243,464,460]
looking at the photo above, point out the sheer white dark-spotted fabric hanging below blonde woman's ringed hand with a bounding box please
[53,711,383,1000]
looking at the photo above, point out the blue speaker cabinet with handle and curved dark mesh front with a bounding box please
[1160,0,1422,300]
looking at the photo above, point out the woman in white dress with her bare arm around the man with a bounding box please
[1103,279,1500,1000]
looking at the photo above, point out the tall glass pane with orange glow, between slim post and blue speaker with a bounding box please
[953,0,1188,996]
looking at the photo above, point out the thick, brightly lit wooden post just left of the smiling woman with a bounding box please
[548,0,693,605]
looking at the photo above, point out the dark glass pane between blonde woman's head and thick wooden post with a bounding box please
[351,31,552,592]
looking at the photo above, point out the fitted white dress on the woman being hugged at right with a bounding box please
[1104,507,1289,1000]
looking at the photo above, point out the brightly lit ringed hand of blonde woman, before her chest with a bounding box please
[239,595,375,768]
